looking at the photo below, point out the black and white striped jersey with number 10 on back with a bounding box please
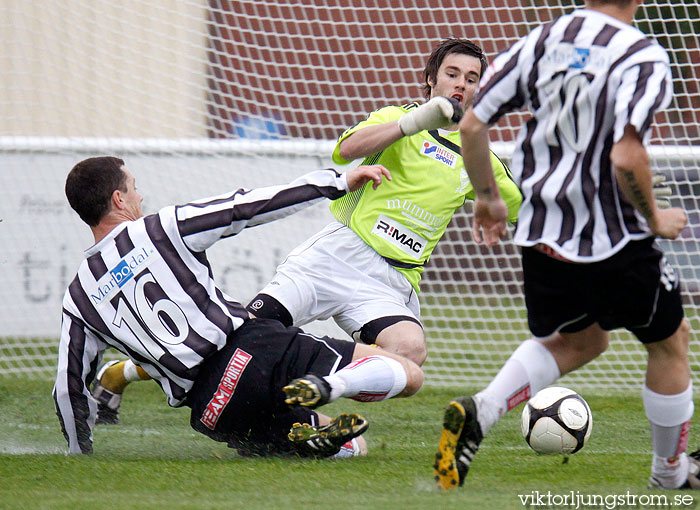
[474,9,672,262]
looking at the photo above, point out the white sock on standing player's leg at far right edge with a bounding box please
[642,382,694,488]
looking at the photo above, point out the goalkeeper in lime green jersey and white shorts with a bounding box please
[243,39,521,364]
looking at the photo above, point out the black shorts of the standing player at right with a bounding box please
[522,238,683,343]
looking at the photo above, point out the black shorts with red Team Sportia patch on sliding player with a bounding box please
[186,319,355,455]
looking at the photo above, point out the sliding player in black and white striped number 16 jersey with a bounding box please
[53,157,423,456]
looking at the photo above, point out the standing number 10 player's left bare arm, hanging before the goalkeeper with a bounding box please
[459,108,508,246]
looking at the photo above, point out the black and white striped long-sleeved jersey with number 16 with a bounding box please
[54,169,348,453]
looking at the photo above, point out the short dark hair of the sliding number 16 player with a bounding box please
[66,156,126,227]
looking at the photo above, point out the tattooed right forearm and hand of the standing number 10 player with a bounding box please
[610,126,688,239]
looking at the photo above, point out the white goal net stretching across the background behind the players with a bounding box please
[0,0,700,391]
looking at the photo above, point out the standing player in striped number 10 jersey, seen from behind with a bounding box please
[434,0,700,489]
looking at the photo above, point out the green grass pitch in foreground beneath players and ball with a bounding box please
[0,378,700,510]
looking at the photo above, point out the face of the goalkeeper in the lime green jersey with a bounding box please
[428,53,481,109]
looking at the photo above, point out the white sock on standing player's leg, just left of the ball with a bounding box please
[475,339,561,434]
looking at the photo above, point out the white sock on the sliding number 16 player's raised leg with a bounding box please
[324,356,406,402]
